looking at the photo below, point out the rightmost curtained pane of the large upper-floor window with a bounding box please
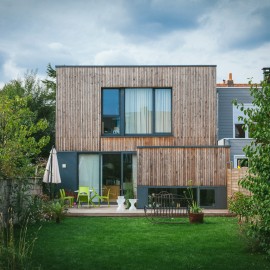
[155,89,172,133]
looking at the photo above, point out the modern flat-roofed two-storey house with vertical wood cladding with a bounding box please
[56,65,232,208]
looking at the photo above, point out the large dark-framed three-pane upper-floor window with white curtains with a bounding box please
[102,88,172,136]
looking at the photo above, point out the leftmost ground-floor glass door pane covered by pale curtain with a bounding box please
[79,154,99,201]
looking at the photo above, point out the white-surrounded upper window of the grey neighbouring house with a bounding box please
[233,103,254,138]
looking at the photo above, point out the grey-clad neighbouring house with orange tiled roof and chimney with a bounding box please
[217,73,254,168]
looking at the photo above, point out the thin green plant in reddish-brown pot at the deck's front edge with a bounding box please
[184,180,204,223]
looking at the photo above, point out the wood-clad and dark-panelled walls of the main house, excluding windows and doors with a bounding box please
[56,66,230,207]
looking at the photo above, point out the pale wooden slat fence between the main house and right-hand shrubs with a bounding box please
[227,167,251,198]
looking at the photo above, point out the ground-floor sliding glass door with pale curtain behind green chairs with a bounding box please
[79,153,137,202]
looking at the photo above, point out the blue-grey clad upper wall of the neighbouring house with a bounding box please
[217,87,252,140]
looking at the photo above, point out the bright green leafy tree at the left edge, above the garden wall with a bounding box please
[0,95,49,178]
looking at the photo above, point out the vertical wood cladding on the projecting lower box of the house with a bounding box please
[137,147,229,186]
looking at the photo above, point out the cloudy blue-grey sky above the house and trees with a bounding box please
[0,0,270,88]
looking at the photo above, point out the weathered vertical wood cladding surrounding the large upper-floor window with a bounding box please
[56,66,216,151]
